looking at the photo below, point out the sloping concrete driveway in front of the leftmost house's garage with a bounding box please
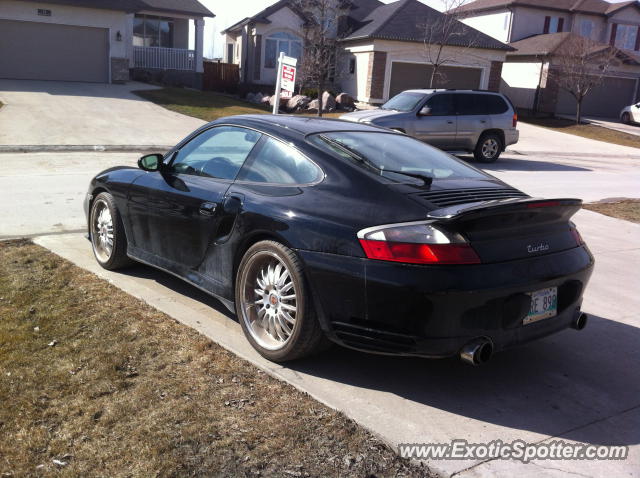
[0,80,204,149]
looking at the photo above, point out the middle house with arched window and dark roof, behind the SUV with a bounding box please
[222,0,511,104]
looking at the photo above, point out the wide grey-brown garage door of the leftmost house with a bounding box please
[0,20,109,82]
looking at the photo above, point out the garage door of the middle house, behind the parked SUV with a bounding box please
[389,61,482,97]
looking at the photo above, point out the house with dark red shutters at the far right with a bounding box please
[459,0,640,117]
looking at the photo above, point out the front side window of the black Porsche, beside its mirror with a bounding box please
[171,126,262,179]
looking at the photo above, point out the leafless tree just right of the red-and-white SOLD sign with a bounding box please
[293,0,348,116]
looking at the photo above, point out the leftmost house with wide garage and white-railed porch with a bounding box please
[0,0,214,87]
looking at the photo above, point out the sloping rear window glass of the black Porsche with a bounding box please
[309,131,487,179]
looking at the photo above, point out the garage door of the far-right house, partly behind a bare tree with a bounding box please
[556,78,636,118]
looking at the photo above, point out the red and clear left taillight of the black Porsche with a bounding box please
[358,222,480,264]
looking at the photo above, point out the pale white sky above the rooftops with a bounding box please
[200,0,624,58]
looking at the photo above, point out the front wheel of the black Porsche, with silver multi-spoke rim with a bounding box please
[89,193,133,271]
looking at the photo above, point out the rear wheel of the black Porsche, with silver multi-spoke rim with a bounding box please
[235,241,325,362]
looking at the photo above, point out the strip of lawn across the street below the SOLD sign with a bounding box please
[135,88,343,121]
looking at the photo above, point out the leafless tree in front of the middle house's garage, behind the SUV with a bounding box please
[420,0,479,88]
